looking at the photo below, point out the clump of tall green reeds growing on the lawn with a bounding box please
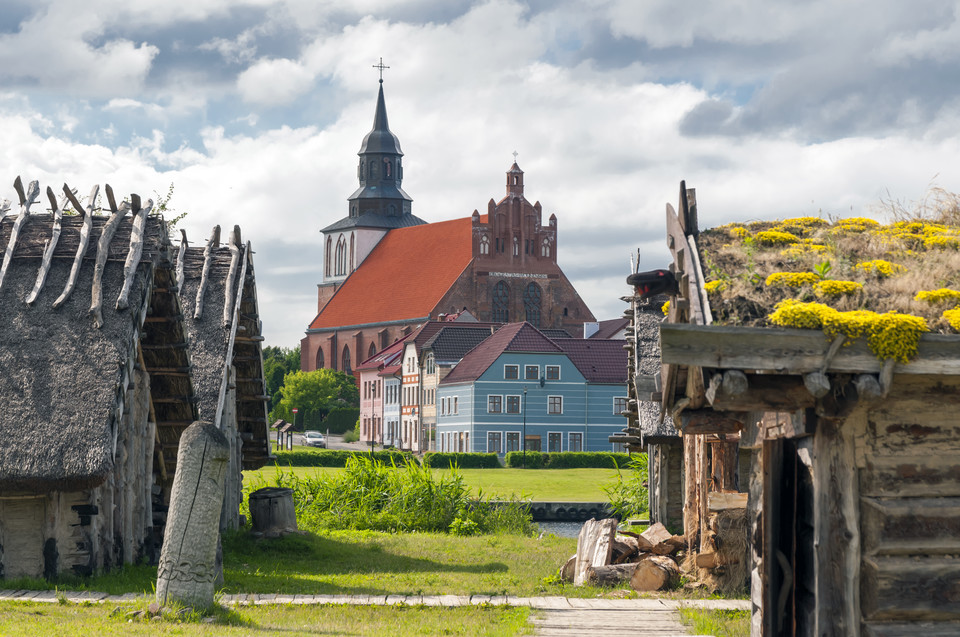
[244,456,536,535]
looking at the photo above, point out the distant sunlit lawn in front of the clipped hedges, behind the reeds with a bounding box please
[243,467,617,502]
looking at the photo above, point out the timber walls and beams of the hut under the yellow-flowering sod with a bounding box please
[648,182,960,636]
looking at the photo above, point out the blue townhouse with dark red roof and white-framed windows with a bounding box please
[437,322,627,454]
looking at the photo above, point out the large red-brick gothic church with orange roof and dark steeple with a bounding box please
[300,80,595,373]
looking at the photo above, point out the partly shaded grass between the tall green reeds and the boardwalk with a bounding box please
[0,531,600,600]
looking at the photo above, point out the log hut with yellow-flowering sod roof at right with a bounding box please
[640,184,960,635]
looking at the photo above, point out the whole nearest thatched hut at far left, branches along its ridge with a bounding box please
[0,179,268,578]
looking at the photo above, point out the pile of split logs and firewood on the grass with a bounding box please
[560,518,686,592]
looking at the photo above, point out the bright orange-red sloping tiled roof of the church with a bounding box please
[309,215,486,329]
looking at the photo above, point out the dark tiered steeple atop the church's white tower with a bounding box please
[347,77,413,219]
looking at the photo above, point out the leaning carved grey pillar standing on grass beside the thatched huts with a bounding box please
[157,422,230,608]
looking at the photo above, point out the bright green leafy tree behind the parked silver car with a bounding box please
[270,369,360,422]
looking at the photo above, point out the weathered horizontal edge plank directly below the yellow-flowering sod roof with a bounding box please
[660,323,960,375]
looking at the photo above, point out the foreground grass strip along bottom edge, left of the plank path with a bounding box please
[0,602,533,637]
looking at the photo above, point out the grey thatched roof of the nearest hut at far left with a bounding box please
[0,206,195,492]
